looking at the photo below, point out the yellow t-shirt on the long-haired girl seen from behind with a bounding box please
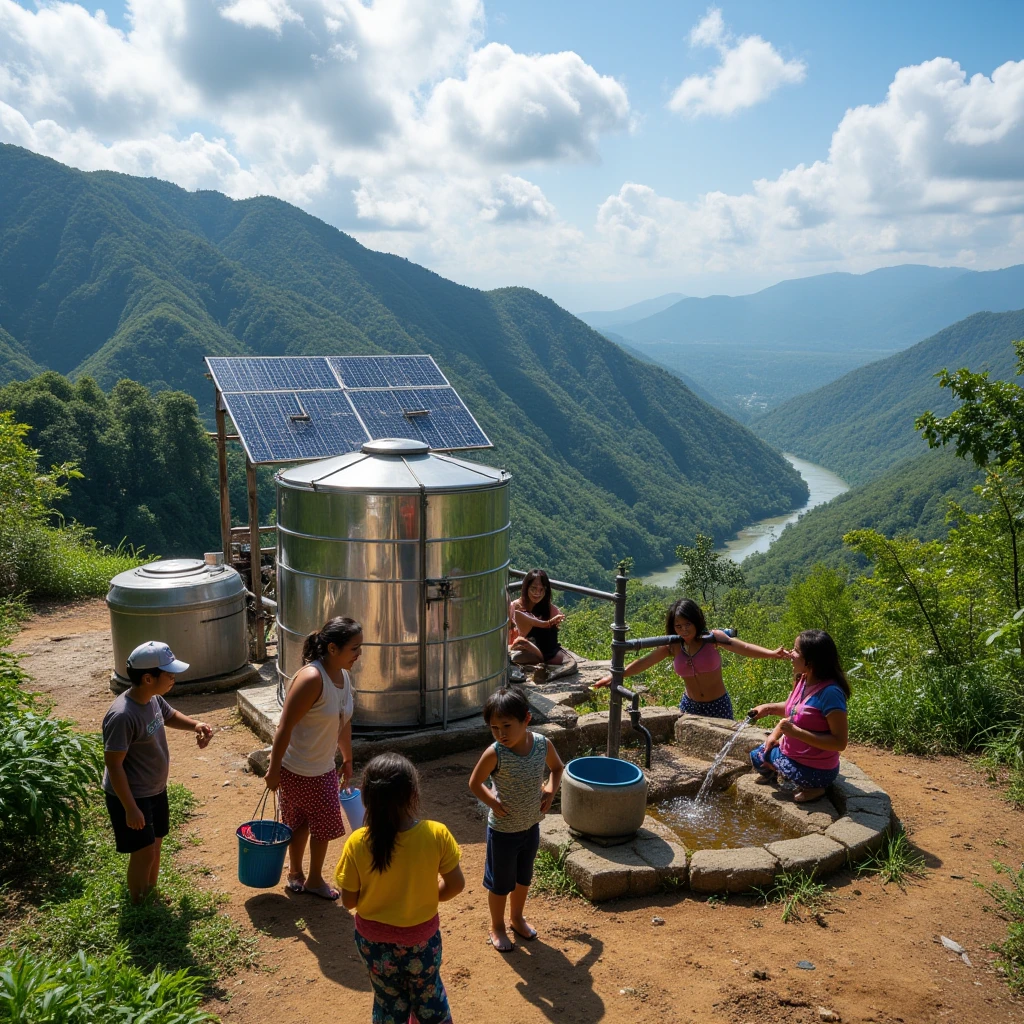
[334,821,462,928]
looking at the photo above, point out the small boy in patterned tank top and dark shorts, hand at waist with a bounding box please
[469,686,564,952]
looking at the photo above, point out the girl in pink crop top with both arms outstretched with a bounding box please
[594,597,790,719]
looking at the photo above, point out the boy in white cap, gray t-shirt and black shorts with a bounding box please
[103,640,213,903]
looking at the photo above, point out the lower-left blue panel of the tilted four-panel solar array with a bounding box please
[224,388,370,464]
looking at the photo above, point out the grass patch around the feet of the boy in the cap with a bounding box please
[7,785,258,990]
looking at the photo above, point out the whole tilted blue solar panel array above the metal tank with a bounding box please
[206,355,490,465]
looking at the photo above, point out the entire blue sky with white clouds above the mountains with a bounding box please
[6,0,1024,310]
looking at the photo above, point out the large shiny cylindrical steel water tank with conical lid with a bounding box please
[276,439,509,727]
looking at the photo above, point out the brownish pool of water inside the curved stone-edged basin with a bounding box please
[647,786,804,851]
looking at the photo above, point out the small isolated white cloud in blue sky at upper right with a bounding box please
[669,7,807,117]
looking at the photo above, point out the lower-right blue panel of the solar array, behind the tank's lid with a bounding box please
[348,387,490,451]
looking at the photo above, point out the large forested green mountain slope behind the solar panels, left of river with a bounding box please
[0,145,806,582]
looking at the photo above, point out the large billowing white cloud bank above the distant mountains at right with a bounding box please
[597,57,1024,273]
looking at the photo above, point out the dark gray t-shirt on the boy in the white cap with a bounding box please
[103,690,174,797]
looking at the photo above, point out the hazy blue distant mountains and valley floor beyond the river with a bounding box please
[602,265,1024,421]
